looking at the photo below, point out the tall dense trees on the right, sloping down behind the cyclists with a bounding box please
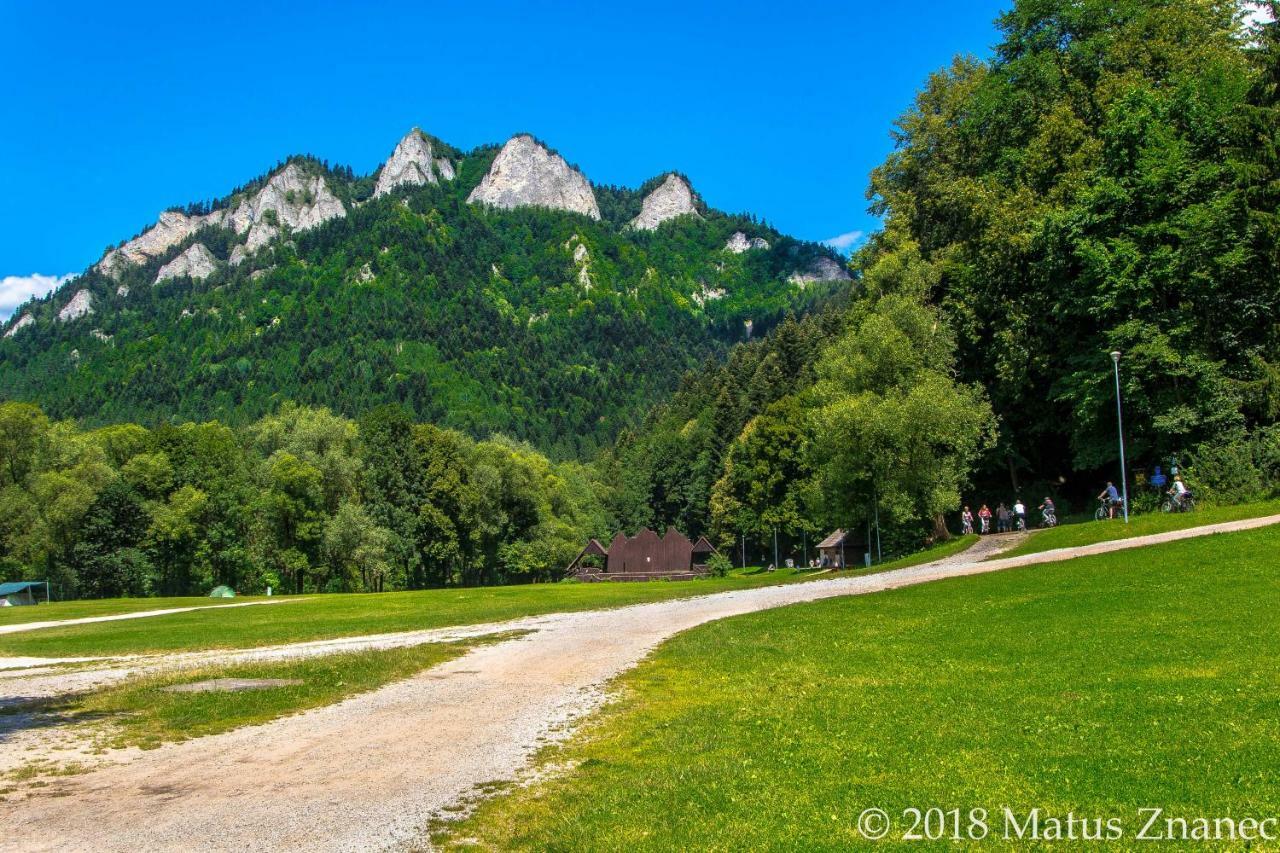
[614,0,1280,550]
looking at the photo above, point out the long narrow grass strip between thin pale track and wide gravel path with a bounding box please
[0,537,974,657]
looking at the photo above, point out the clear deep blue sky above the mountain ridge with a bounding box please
[0,0,1007,316]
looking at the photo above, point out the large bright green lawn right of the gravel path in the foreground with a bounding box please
[436,528,1280,850]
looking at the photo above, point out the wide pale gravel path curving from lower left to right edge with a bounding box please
[0,516,1280,850]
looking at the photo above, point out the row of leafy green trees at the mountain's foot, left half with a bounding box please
[0,402,608,597]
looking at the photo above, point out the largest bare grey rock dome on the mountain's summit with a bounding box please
[467,134,600,219]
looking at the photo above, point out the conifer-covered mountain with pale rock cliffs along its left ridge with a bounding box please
[0,132,838,459]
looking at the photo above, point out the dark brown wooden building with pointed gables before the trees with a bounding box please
[566,528,716,580]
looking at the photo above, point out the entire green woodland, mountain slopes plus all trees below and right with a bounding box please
[0,0,1280,596]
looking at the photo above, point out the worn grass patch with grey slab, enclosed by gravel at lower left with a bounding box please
[10,634,509,749]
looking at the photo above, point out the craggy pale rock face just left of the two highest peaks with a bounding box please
[227,163,347,251]
